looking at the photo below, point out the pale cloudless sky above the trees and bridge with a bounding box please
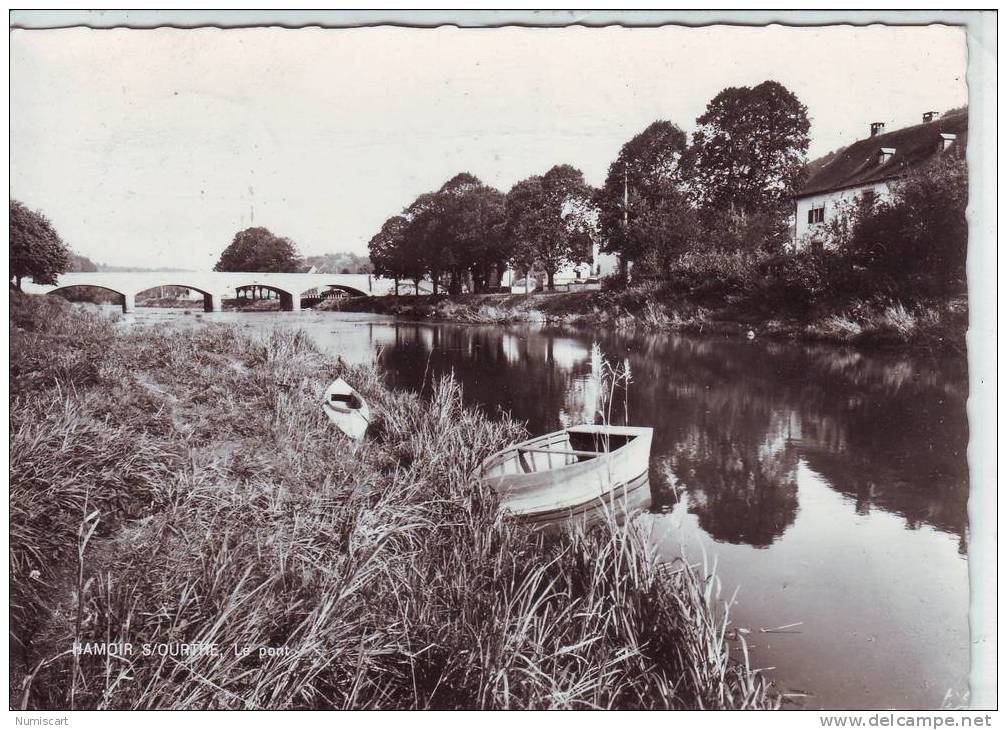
[10,25,968,270]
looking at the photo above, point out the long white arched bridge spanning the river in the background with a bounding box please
[21,271,395,312]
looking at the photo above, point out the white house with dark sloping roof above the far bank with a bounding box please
[794,109,969,249]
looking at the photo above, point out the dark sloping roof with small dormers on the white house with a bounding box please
[796,109,969,197]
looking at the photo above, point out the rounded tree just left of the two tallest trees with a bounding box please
[506,165,597,289]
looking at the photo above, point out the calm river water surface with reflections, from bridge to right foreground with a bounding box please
[125,310,969,709]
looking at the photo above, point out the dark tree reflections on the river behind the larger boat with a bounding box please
[381,323,968,550]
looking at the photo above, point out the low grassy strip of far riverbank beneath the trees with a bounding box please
[338,284,969,352]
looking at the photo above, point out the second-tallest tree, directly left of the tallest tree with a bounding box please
[596,120,696,272]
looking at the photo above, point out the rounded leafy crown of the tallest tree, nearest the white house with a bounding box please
[686,82,811,221]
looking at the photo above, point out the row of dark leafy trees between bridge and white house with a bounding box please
[370,82,810,293]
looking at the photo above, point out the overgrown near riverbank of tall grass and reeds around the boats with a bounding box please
[10,295,774,709]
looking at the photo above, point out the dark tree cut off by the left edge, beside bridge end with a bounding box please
[9,199,70,291]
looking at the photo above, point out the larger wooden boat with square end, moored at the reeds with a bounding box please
[479,425,654,522]
